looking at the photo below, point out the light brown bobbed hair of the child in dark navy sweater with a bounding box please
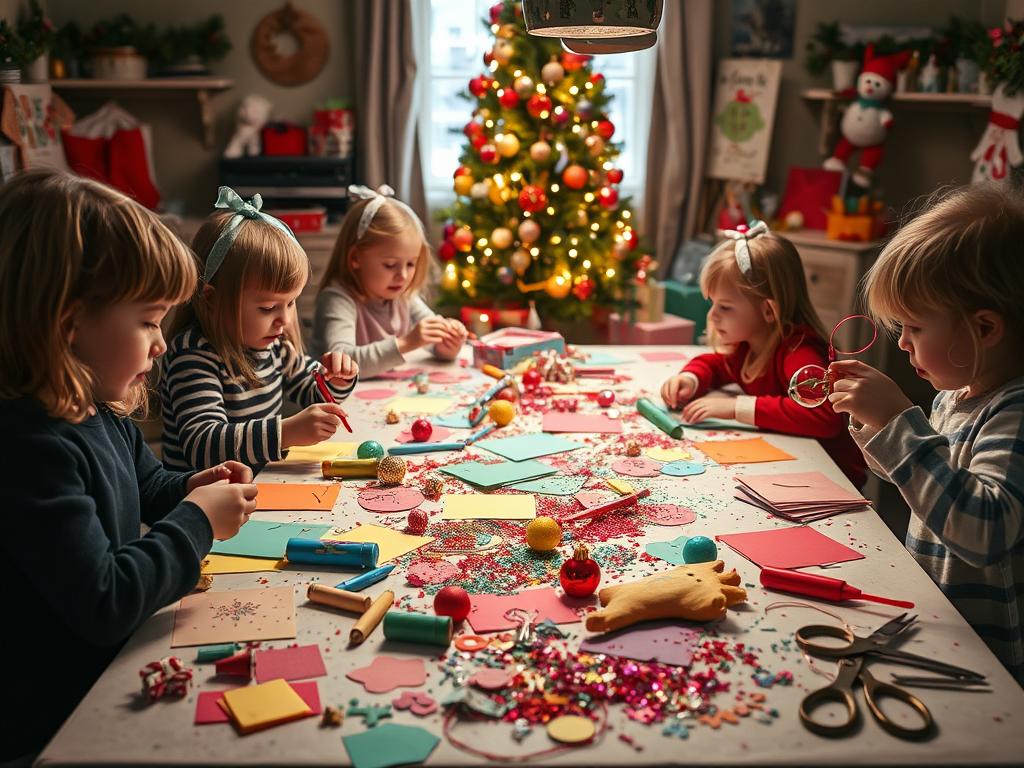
[0,170,199,423]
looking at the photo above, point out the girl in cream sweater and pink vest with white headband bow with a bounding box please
[312,185,467,377]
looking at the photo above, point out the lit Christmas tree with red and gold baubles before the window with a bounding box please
[437,0,651,321]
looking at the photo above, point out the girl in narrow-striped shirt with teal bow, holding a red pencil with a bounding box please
[161,186,358,468]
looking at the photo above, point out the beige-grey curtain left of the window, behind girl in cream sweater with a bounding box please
[352,0,428,222]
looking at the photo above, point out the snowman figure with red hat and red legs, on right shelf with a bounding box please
[823,45,910,187]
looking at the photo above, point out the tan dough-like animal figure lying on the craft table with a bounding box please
[587,560,746,632]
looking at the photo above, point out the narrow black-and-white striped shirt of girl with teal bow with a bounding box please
[160,328,355,469]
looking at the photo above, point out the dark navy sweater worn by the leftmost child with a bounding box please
[0,399,213,760]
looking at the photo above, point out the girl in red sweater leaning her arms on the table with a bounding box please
[662,222,865,486]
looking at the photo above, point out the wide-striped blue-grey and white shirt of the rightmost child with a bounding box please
[850,378,1024,685]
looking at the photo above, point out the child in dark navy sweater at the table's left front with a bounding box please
[0,171,256,765]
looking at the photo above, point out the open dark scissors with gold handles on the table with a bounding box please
[797,613,985,739]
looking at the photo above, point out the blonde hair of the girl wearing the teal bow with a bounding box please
[171,211,309,386]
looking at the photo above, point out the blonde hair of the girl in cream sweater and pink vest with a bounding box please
[318,199,432,302]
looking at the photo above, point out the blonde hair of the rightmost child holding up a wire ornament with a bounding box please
[863,183,1024,377]
